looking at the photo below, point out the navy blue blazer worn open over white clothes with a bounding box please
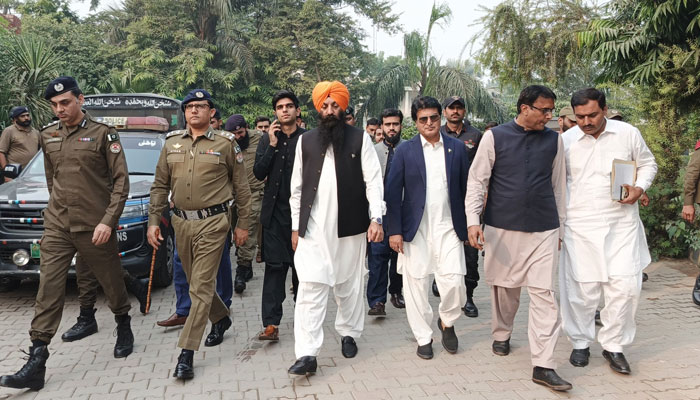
[384,134,471,242]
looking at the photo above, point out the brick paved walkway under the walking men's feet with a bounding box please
[0,261,700,400]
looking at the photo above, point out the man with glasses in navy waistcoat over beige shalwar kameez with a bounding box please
[465,85,571,391]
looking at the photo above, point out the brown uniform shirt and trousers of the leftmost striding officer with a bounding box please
[29,115,131,343]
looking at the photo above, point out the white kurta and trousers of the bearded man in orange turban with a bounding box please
[289,135,386,358]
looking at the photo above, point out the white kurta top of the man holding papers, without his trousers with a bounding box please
[561,120,657,282]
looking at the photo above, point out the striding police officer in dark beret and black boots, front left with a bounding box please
[0,76,134,390]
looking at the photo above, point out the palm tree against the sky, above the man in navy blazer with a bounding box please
[358,3,506,121]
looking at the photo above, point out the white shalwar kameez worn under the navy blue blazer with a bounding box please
[397,136,467,346]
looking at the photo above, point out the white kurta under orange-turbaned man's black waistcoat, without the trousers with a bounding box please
[289,131,386,286]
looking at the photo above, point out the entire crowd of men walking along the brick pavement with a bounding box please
[0,77,700,391]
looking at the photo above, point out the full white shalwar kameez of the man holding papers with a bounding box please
[559,120,657,353]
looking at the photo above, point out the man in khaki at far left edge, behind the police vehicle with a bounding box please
[0,106,39,182]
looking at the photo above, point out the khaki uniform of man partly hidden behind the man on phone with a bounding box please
[232,130,265,266]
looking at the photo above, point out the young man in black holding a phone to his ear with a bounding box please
[253,90,304,341]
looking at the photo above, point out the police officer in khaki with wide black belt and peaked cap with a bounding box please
[148,89,250,379]
